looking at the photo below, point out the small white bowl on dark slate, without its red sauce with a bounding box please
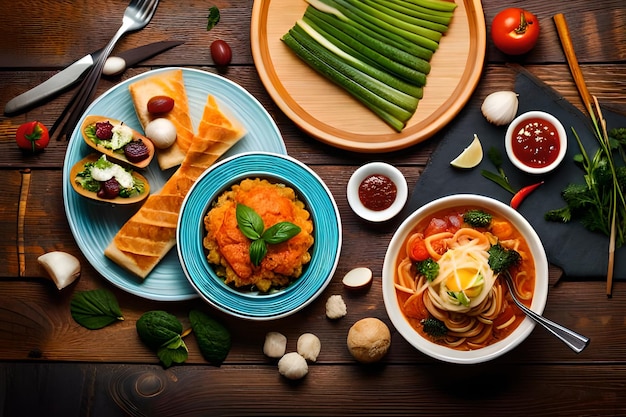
[504,111,567,175]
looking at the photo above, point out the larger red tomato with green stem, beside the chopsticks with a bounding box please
[491,7,539,55]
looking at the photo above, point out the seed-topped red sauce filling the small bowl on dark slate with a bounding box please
[512,118,561,168]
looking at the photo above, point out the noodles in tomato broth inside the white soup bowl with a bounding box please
[395,208,535,350]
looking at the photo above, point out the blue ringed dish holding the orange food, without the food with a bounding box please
[176,152,342,320]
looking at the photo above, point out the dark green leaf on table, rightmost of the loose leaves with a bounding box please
[189,310,231,366]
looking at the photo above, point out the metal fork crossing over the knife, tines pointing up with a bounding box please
[50,0,159,140]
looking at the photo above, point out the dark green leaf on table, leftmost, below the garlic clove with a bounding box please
[70,289,124,330]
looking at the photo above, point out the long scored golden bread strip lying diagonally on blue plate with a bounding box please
[104,96,245,278]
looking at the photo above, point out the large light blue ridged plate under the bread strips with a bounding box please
[63,68,287,301]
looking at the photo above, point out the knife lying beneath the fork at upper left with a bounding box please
[4,41,184,115]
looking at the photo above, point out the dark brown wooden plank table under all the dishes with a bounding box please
[0,0,626,417]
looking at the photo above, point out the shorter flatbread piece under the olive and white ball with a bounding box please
[128,69,194,170]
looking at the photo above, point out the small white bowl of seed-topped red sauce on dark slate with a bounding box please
[505,111,567,174]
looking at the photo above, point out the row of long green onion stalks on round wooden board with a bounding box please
[281,0,456,132]
